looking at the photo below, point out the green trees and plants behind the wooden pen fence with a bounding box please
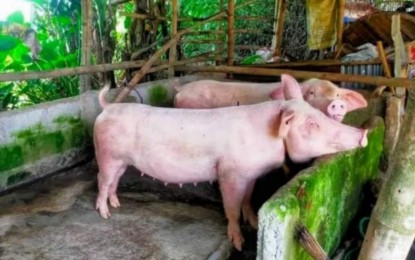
[0,0,274,110]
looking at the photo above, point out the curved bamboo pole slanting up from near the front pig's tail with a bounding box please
[114,0,264,102]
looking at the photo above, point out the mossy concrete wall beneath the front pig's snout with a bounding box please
[257,117,384,260]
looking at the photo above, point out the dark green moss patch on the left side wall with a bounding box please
[0,116,91,186]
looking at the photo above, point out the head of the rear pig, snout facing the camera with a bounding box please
[270,79,367,122]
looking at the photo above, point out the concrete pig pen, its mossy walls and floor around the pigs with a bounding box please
[0,76,384,259]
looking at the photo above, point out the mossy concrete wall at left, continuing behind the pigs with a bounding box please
[0,76,221,193]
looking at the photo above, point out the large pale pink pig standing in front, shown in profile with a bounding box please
[94,75,367,250]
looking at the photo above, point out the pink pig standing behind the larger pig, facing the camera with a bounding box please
[175,79,367,122]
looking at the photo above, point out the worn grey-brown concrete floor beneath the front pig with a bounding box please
[0,163,240,260]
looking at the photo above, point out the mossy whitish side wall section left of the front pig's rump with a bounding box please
[0,98,91,192]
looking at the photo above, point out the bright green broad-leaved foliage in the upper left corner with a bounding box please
[0,0,81,110]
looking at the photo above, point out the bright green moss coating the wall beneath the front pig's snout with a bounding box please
[264,118,384,259]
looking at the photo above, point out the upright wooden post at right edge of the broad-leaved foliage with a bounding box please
[79,0,92,93]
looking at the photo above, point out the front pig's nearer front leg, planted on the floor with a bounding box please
[218,174,248,251]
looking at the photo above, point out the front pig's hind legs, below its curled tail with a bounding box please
[96,159,126,218]
